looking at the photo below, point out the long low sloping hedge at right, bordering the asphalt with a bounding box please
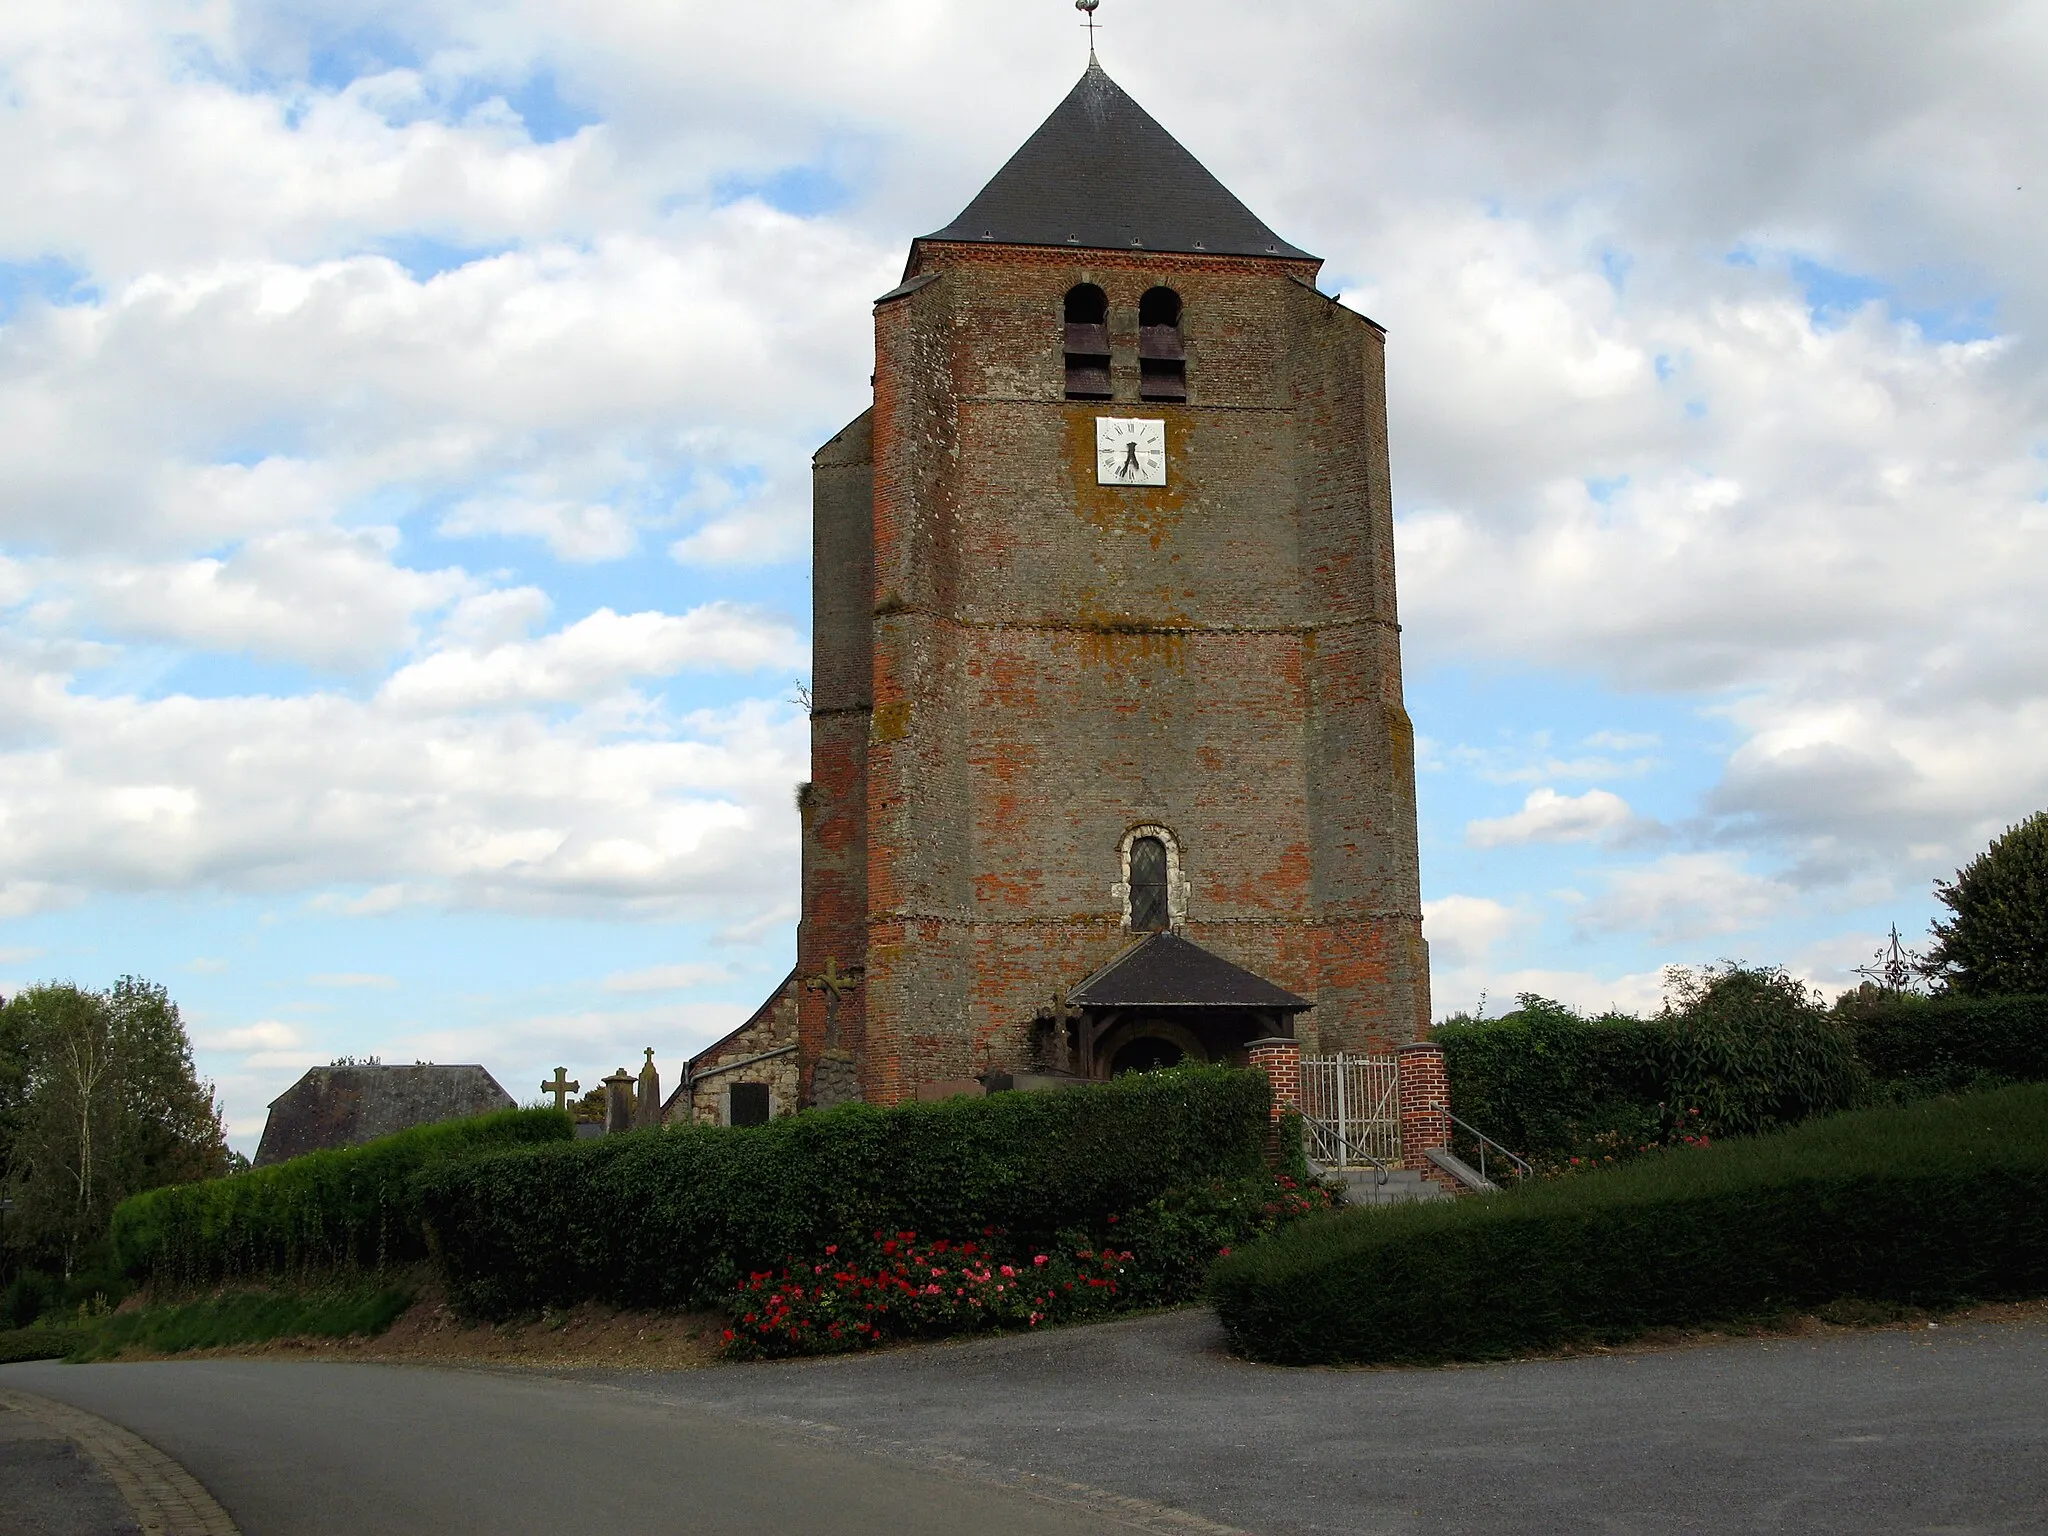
[1210,1085,2048,1364]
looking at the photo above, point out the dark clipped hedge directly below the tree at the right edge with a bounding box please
[1847,997,2048,1098]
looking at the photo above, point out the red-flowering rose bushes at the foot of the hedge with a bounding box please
[725,1174,1335,1360]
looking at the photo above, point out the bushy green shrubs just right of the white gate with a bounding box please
[1432,965,1868,1165]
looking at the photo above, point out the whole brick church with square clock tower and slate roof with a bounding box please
[668,57,1430,1124]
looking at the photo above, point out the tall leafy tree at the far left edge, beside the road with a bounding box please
[0,977,227,1276]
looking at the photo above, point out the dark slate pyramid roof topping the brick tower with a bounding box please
[926,57,1315,260]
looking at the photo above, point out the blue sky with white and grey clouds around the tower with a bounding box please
[0,0,2048,1151]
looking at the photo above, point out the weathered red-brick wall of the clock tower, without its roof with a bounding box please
[799,244,1430,1102]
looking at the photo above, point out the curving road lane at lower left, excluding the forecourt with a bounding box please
[0,1360,1128,1536]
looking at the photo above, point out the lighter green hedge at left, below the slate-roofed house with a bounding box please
[113,1110,575,1290]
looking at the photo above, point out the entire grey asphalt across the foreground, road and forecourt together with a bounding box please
[0,1313,2048,1536]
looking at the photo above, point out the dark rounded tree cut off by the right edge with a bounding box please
[1927,811,2048,997]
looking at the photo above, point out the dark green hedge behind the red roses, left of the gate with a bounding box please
[420,1067,1270,1317]
